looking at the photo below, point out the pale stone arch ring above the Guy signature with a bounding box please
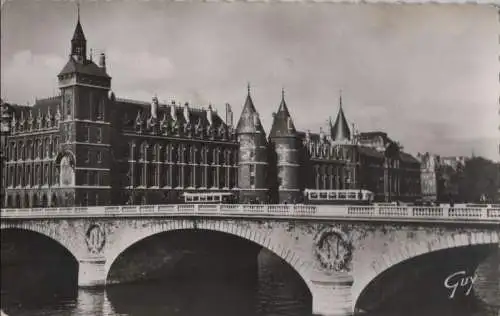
[352,231,500,307]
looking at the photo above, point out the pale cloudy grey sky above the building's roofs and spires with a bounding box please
[0,0,500,161]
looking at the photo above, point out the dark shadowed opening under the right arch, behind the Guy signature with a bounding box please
[354,243,497,315]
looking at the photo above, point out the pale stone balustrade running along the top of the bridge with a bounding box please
[0,204,500,224]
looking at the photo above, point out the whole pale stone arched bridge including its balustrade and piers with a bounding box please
[1,205,500,315]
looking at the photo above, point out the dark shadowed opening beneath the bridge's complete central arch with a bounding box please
[106,228,312,316]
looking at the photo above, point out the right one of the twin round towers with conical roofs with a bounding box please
[269,91,301,203]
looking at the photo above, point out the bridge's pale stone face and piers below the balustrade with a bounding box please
[1,216,500,316]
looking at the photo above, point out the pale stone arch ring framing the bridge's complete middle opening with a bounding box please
[105,220,313,293]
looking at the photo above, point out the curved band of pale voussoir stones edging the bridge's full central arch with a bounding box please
[105,223,313,295]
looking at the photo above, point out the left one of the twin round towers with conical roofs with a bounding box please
[236,87,269,203]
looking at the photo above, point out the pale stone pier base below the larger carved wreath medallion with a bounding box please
[310,275,353,316]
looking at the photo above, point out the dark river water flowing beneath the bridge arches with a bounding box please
[2,247,500,316]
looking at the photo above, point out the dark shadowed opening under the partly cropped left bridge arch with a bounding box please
[0,227,79,314]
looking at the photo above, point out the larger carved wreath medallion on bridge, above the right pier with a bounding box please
[314,228,352,272]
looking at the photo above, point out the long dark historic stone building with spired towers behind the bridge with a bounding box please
[1,14,420,207]
